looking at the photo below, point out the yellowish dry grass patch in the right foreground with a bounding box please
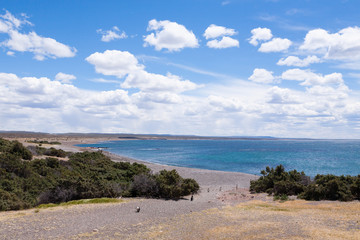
[133,200,360,240]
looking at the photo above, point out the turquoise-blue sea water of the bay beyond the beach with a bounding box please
[79,140,360,176]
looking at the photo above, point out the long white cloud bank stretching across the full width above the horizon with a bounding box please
[0,70,360,137]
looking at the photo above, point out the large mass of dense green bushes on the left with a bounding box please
[0,138,199,210]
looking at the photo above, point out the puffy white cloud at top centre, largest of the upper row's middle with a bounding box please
[144,19,199,52]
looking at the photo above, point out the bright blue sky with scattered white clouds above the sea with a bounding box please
[0,0,360,139]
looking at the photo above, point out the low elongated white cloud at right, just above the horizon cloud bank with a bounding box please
[281,68,344,86]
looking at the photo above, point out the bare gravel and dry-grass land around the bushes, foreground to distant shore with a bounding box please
[0,132,360,239]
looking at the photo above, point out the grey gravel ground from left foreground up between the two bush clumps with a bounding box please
[0,166,253,240]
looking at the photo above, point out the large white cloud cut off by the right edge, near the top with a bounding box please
[300,27,360,60]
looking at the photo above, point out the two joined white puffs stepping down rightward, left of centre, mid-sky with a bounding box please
[86,50,199,93]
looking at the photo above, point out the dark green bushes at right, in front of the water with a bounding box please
[250,165,360,201]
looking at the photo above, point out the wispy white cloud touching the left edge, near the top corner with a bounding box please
[0,12,76,61]
